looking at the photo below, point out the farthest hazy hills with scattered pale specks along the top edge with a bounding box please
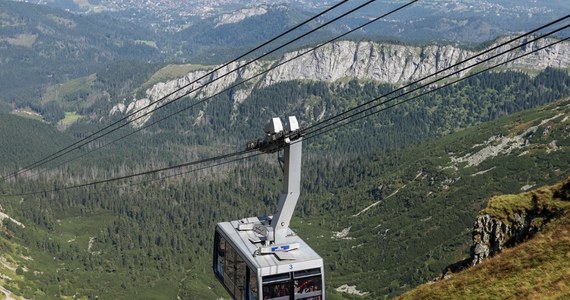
[8,0,570,43]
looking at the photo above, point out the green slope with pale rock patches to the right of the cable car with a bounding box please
[297,100,570,298]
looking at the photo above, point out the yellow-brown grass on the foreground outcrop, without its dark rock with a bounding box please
[402,178,570,299]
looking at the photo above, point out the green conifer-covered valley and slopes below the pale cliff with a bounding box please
[0,65,570,299]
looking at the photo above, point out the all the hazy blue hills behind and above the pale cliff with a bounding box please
[0,0,567,124]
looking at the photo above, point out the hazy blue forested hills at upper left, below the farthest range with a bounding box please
[0,1,318,116]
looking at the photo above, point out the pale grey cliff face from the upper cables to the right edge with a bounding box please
[261,40,570,87]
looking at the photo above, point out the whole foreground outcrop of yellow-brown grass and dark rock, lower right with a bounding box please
[401,178,570,299]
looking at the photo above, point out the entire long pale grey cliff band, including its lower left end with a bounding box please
[110,40,570,126]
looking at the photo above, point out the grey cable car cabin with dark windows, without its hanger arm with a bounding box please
[213,218,325,300]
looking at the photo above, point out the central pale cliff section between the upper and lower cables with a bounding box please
[262,41,473,86]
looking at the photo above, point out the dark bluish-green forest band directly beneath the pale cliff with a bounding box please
[144,68,570,155]
